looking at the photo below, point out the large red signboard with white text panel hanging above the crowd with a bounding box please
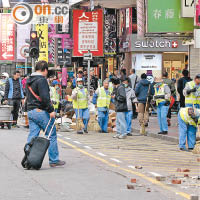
[73,9,103,57]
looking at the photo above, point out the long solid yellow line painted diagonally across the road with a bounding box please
[58,138,190,199]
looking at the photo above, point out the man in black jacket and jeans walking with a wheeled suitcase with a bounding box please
[27,61,65,167]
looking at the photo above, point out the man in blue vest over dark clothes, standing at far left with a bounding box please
[4,71,24,128]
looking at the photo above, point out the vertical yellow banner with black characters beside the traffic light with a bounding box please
[36,24,48,62]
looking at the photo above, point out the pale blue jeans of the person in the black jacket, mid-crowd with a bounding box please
[116,112,127,135]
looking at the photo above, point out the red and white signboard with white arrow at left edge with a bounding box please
[0,13,15,61]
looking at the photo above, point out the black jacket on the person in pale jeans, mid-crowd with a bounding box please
[114,84,128,112]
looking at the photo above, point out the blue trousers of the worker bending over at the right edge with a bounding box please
[178,114,197,149]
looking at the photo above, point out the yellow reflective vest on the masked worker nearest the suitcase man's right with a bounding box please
[73,88,88,109]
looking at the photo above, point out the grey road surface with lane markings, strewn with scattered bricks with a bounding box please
[0,128,200,200]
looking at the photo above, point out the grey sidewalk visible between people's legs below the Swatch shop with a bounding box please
[132,115,179,143]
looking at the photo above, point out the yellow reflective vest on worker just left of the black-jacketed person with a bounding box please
[97,87,111,108]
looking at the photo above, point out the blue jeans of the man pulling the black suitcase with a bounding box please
[27,109,59,164]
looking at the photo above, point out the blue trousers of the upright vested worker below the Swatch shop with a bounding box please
[157,104,169,132]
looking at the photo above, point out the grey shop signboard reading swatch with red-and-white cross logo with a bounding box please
[131,35,188,52]
